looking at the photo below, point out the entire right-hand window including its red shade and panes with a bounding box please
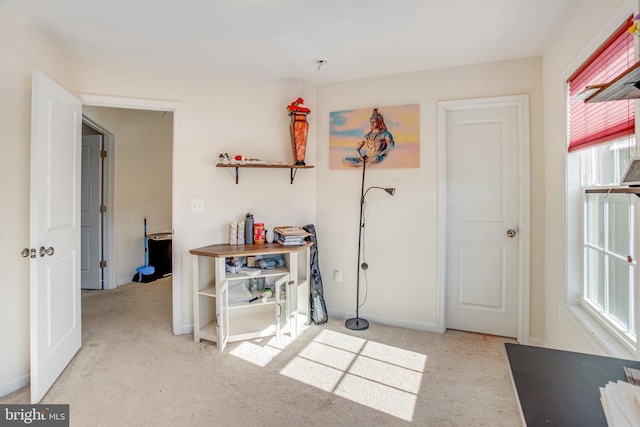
[567,18,639,354]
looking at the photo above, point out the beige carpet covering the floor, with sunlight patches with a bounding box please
[0,278,521,427]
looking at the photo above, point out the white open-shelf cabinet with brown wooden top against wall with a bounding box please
[189,242,313,351]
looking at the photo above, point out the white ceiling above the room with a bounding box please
[0,0,580,83]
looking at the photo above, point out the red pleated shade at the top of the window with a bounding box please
[567,17,635,151]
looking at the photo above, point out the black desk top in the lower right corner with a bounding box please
[505,343,640,427]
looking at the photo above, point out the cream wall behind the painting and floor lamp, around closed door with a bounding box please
[317,58,544,340]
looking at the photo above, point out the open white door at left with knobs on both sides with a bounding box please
[30,71,82,403]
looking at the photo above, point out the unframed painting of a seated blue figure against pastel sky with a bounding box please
[329,104,420,169]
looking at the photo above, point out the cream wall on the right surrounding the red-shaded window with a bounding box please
[543,0,637,354]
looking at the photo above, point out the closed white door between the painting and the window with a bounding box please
[446,97,520,337]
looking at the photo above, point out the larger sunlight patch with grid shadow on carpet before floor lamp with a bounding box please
[280,330,427,421]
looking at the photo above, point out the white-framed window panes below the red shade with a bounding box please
[579,136,637,348]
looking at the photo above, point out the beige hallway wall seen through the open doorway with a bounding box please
[84,107,173,285]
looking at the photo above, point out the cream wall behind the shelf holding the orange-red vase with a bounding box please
[68,60,316,332]
